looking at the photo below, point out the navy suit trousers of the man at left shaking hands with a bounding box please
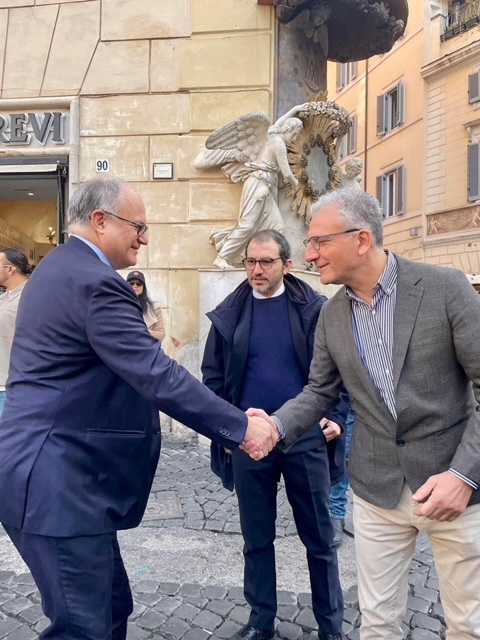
[4,525,133,640]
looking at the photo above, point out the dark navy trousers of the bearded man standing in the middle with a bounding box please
[233,447,343,633]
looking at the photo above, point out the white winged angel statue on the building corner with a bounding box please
[194,104,306,269]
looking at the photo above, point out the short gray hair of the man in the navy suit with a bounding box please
[67,180,127,227]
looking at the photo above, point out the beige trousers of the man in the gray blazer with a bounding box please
[353,486,480,640]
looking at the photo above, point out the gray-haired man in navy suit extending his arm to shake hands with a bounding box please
[0,180,278,640]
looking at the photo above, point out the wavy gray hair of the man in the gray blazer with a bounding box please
[311,189,383,247]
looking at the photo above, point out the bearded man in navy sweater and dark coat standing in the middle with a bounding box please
[202,229,350,640]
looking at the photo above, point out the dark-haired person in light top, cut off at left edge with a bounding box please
[0,249,34,416]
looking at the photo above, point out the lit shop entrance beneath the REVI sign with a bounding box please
[0,157,68,264]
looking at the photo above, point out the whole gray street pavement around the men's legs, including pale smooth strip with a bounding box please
[0,436,445,640]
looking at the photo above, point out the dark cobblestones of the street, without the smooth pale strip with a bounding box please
[0,440,445,640]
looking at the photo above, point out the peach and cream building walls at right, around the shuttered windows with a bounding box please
[328,0,480,274]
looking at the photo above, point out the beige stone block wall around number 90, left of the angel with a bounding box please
[0,0,275,356]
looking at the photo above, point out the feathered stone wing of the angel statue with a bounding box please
[193,111,271,177]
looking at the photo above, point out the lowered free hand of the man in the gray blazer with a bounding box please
[412,471,473,522]
